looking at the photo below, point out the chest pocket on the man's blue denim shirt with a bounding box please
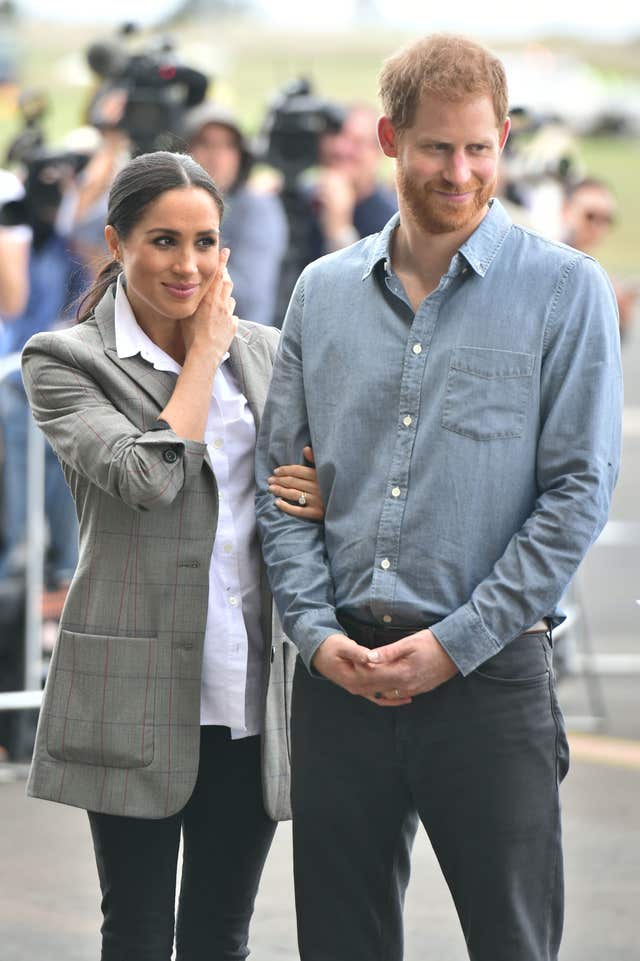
[441,347,535,441]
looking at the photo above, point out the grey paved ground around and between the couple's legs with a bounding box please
[0,748,640,961]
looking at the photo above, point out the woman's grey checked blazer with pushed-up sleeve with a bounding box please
[22,290,296,819]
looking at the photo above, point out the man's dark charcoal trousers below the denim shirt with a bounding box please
[292,629,568,961]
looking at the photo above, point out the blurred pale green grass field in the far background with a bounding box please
[0,21,640,275]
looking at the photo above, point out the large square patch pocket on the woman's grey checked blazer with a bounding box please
[47,630,157,768]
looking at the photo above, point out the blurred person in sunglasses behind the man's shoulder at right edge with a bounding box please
[562,177,640,339]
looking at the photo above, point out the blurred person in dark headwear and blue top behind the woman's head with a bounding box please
[184,101,288,325]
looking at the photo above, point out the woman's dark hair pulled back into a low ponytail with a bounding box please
[77,150,224,323]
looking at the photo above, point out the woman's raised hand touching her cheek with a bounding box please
[182,247,238,364]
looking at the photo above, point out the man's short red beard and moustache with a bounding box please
[396,164,496,234]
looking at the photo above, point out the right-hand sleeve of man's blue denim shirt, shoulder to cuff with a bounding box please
[432,257,622,674]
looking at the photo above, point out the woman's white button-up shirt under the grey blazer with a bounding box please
[115,275,264,738]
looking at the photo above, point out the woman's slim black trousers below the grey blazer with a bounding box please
[89,727,276,961]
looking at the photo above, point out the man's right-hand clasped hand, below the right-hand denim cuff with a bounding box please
[368,630,458,707]
